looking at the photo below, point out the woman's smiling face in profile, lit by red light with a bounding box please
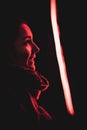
[14,23,40,70]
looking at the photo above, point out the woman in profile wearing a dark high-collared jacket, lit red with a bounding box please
[0,18,56,130]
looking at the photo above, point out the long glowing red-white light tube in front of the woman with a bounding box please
[50,0,75,115]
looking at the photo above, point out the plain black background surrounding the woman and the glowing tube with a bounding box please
[1,0,87,130]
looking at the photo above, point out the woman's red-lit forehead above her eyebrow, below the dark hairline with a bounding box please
[19,23,33,38]
